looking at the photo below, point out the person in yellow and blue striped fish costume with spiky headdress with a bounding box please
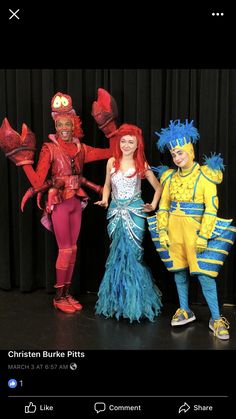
[148,120,236,340]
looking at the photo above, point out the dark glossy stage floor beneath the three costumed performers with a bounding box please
[0,290,236,350]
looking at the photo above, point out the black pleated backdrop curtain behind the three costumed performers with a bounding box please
[0,69,236,304]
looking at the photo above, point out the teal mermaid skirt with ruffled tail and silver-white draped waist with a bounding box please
[95,196,162,322]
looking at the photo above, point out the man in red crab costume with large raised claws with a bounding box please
[0,88,117,313]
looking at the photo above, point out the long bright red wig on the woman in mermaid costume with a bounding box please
[114,124,148,179]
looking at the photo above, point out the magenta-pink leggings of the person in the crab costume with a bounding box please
[52,196,82,287]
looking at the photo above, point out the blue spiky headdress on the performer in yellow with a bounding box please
[155,119,199,152]
